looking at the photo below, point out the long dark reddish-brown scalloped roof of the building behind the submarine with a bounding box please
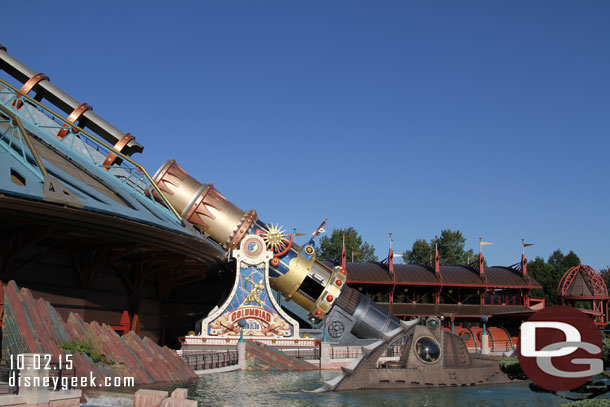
[324,261,541,288]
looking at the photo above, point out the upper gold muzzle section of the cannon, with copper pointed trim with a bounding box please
[153,160,257,249]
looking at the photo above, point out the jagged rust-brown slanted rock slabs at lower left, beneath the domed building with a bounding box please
[2,281,197,385]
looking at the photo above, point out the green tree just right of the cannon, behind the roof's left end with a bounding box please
[317,226,377,263]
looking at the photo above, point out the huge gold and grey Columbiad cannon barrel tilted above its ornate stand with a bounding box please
[153,160,400,344]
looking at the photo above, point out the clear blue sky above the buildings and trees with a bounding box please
[0,1,610,269]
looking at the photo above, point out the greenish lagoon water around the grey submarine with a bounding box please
[83,371,562,407]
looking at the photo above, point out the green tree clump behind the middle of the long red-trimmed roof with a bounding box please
[402,229,475,265]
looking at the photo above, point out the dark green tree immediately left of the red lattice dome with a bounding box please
[527,249,580,305]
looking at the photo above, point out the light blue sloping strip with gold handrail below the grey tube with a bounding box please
[0,79,182,224]
